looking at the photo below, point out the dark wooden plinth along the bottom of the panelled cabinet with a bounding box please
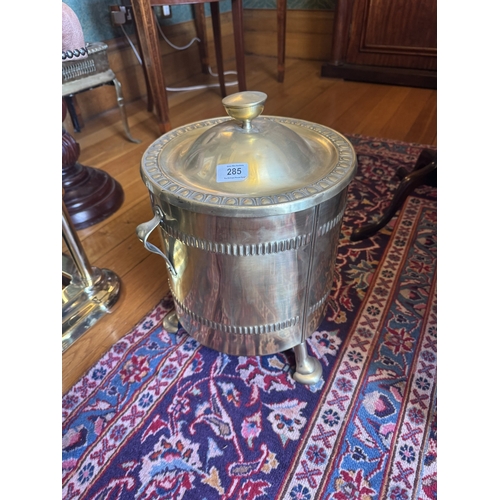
[321,63,437,89]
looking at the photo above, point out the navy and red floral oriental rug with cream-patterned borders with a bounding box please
[62,136,437,500]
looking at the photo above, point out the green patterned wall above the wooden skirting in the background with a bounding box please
[64,0,336,42]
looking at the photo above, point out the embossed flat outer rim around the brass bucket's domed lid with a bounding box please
[141,116,357,217]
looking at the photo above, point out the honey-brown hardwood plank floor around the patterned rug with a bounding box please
[62,52,437,393]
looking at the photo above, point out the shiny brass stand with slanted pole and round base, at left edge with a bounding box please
[62,197,121,352]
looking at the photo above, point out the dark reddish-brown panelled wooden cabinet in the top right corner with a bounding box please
[321,0,437,88]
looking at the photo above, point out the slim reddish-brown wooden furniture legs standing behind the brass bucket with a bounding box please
[130,0,286,134]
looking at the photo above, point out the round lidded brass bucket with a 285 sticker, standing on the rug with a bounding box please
[137,92,357,384]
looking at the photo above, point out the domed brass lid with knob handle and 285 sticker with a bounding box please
[141,92,357,217]
